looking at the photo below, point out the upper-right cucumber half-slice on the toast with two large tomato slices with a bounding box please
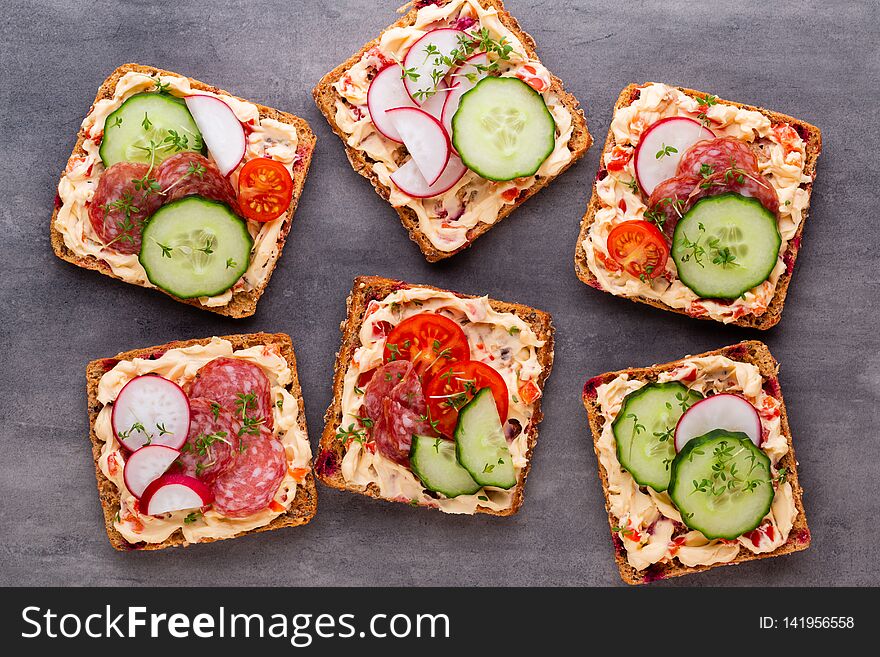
[455,388,516,488]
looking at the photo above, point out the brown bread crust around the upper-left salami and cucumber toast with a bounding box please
[50,64,316,318]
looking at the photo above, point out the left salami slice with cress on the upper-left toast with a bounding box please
[89,162,162,253]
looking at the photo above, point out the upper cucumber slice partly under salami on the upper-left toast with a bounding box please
[100,92,205,167]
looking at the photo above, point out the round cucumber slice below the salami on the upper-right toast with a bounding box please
[672,193,782,299]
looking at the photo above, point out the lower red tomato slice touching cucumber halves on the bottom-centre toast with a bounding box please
[425,360,509,438]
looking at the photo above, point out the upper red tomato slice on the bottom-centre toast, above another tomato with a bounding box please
[385,313,471,381]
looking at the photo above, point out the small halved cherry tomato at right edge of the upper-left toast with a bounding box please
[238,157,293,222]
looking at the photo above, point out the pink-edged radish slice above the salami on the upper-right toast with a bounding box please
[633,116,715,196]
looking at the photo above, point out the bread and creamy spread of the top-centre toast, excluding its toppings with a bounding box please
[313,0,592,262]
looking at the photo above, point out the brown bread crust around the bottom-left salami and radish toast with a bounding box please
[86,333,318,551]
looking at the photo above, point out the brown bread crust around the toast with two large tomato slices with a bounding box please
[315,276,554,516]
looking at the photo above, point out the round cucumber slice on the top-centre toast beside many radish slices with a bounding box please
[452,77,556,181]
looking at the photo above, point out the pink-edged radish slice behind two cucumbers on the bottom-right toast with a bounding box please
[675,393,762,452]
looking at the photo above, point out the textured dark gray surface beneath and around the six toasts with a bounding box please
[0,0,880,586]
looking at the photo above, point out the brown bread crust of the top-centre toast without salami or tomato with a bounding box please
[312,0,593,262]
